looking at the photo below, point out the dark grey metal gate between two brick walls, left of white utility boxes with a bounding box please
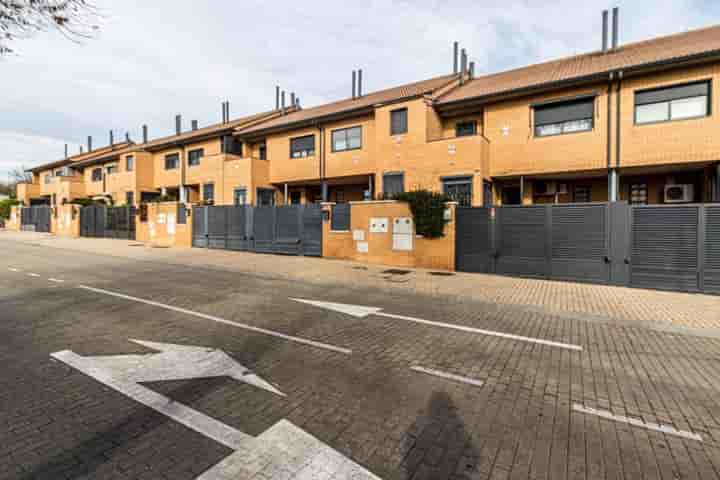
[192,204,322,256]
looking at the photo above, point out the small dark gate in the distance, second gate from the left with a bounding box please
[80,205,135,240]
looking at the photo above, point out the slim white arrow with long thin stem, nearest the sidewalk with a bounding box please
[290,298,583,352]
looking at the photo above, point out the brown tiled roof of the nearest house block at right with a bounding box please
[435,25,720,107]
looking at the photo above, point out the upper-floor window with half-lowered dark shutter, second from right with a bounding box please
[533,97,595,137]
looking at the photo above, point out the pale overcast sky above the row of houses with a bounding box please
[0,0,720,179]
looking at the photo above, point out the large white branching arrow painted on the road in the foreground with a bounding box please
[51,340,378,480]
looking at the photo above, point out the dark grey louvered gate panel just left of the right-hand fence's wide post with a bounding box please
[550,204,610,283]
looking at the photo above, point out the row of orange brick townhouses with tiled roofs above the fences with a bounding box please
[18,15,720,206]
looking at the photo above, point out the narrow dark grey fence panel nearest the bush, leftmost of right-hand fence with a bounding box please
[455,207,493,273]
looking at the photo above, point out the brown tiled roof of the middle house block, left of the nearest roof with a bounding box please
[238,74,458,134]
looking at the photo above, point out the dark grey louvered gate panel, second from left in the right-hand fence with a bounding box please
[496,206,549,278]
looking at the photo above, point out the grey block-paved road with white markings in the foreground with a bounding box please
[0,241,720,480]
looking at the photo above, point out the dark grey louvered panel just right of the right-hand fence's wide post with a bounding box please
[630,205,699,292]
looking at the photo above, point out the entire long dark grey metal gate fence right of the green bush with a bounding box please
[456,202,720,293]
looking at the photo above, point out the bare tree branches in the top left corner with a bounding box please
[0,0,99,56]
